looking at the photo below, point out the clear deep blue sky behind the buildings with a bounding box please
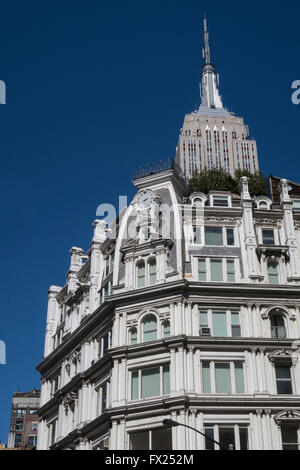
[0,0,300,442]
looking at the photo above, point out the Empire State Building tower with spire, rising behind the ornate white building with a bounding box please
[176,18,259,178]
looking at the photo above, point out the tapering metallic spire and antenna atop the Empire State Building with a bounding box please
[200,16,223,109]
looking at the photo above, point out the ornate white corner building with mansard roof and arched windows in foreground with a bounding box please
[37,19,300,450]
